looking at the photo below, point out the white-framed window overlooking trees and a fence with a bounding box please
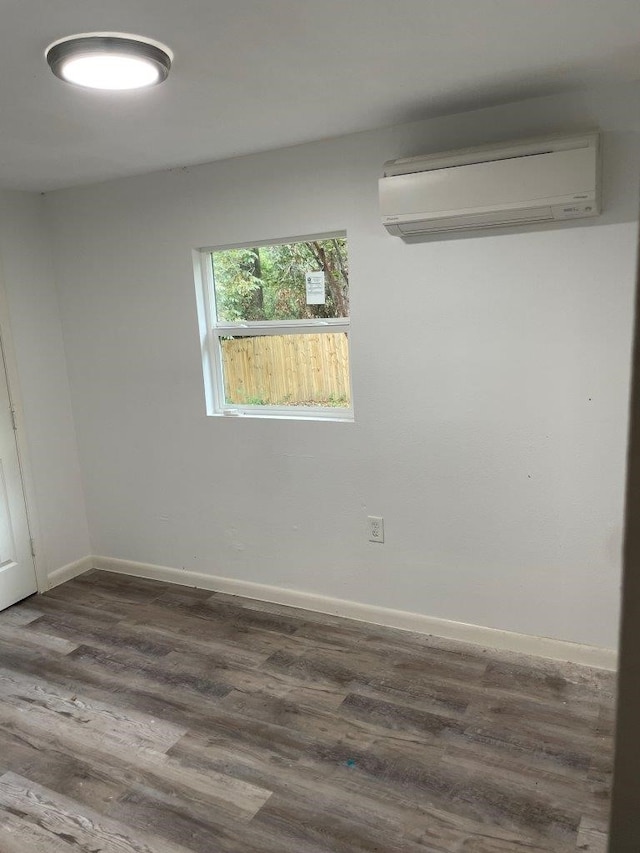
[196,233,353,420]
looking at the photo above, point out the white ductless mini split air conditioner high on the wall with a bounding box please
[380,132,600,239]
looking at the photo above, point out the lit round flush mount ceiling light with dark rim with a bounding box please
[45,33,173,91]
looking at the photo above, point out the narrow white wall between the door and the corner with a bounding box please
[0,192,91,578]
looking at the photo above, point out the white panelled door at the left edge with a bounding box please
[0,340,38,610]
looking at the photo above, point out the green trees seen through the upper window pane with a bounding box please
[212,237,349,322]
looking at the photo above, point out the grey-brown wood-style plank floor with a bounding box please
[0,572,614,853]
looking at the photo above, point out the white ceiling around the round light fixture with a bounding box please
[0,0,640,190]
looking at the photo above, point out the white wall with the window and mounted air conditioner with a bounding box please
[47,88,640,647]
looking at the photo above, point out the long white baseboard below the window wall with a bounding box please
[92,557,617,670]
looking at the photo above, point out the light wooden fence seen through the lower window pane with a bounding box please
[221,332,351,406]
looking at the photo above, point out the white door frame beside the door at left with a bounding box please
[0,258,49,593]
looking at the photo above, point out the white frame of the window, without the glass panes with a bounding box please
[193,231,354,423]
